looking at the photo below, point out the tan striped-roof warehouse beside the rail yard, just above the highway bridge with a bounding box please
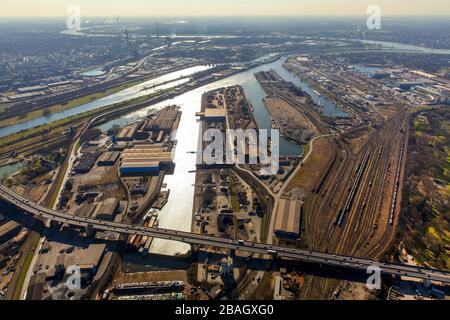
[274,199,302,239]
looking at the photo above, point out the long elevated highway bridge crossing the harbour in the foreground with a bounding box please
[0,186,450,284]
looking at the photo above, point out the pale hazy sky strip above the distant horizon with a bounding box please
[0,0,450,17]
